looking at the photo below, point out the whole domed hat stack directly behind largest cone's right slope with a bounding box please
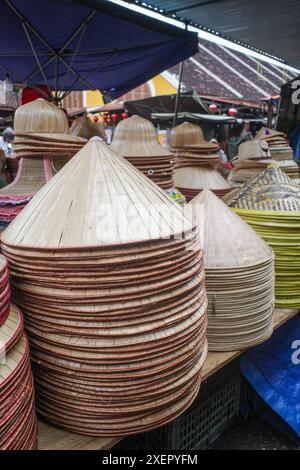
[111,116,185,203]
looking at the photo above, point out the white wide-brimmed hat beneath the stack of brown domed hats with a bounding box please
[174,166,231,189]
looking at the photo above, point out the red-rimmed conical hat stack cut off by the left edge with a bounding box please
[0,256,37,450]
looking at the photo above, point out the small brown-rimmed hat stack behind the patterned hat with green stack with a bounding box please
[255,127,293,160]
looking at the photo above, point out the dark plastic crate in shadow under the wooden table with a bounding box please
[117,360,241,450]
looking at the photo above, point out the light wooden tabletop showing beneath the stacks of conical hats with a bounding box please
[38,309,299,450]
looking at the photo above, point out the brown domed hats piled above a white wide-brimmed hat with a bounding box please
[171,122,231,201]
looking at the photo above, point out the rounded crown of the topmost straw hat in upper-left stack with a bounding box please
[14,98,69,133]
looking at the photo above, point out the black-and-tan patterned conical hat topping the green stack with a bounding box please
[224,166,300,212]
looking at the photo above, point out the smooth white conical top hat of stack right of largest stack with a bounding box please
[190,189,273,269]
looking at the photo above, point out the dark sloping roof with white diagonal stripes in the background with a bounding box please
[170,39,296,102]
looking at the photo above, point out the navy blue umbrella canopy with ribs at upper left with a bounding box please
[0,0,198,99]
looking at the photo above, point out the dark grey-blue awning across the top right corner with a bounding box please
[131,0,300,66]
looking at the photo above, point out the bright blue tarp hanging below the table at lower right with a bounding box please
[241,314,300,437]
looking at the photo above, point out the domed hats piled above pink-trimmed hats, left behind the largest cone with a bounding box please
[0,99,86,229]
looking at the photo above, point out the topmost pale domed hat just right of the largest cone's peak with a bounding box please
[111,116,172,157]
